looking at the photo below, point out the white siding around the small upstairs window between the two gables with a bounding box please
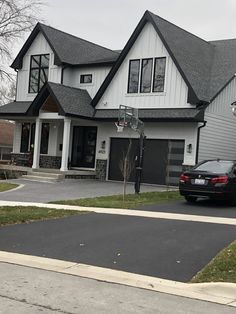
[63,66,111,98]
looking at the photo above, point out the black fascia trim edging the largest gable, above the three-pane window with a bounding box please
[92,11,200,107]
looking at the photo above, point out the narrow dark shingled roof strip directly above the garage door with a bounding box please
[94,108,204,122]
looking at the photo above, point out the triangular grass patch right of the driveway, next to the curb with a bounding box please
[191,240,236,283]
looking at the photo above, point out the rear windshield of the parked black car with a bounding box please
[194,160,234,173]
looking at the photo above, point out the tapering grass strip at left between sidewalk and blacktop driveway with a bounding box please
[0,206,87,226]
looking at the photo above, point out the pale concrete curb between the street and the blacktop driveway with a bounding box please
[0,251,236,307]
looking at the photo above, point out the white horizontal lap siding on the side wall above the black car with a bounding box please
[199,79,236,161]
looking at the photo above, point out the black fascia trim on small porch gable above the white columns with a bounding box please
[26,82,65,116]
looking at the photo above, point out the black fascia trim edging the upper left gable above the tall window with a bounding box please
[11,23,61,69]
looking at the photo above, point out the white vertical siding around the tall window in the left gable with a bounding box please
[16,33,61,101]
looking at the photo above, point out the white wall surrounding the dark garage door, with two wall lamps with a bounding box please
[96,122,198,165]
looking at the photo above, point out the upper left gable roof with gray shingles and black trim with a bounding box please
[11,23,119,69]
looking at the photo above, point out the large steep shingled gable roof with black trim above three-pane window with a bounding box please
[93,11,236,106]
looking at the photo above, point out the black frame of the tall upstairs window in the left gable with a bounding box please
[28,53,50,94]
